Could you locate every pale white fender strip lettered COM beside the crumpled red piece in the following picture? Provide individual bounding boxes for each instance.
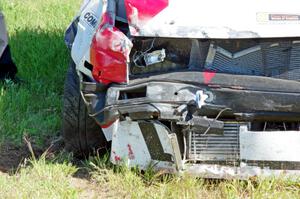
[71,0,106,77]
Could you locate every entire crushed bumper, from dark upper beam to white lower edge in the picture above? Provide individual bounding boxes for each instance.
[83,72,300,178]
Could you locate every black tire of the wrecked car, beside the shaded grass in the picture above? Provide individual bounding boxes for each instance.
[62,62,107,157]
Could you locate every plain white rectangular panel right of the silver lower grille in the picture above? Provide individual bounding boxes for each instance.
[240,126,300,162]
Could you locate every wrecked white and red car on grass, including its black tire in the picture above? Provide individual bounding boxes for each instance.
[63,0,300,178]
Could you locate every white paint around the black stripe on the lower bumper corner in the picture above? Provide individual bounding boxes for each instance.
[111,121,176,172]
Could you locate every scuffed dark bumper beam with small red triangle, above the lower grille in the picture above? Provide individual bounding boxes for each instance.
[90,72,300,124]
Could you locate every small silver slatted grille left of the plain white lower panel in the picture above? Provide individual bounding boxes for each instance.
[187,123,240,163]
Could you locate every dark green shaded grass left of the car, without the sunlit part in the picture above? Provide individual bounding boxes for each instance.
[0,30,69,146]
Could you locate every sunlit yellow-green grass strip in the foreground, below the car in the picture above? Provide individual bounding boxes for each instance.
[0,152,300,199]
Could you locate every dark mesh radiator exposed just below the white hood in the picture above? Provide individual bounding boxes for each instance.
[205,40,300,80]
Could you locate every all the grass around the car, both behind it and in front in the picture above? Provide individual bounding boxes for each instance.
[0,0,300,199]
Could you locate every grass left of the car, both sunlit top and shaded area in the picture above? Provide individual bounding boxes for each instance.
[0,0,80,144]
